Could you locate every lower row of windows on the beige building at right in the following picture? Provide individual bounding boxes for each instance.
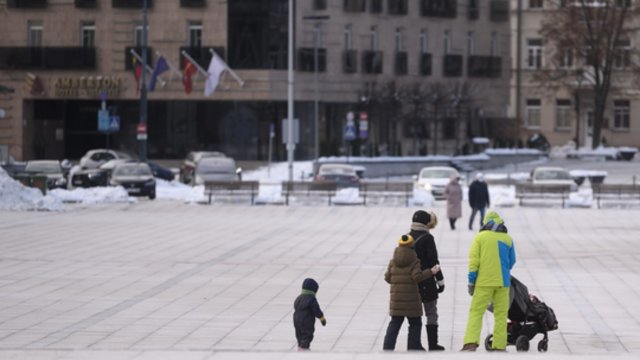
[525,99,631,130]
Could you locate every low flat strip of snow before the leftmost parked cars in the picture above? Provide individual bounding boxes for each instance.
[49,186,136,204]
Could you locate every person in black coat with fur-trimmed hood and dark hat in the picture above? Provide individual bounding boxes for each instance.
[409,210,444,351]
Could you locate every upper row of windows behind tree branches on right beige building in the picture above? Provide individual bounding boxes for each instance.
[525,38,632,69]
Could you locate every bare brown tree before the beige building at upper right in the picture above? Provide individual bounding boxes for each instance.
[534,0,640,148]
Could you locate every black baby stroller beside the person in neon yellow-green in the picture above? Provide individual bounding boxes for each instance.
[484,276,558,352]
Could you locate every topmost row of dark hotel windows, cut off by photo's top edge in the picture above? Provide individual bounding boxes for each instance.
[313,0,509,21]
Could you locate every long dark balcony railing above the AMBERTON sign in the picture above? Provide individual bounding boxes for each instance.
[0,47,96,70]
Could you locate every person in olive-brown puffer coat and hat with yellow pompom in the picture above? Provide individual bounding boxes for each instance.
[383,234,440,351]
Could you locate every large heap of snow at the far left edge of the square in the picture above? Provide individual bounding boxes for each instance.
[0,168,64,211]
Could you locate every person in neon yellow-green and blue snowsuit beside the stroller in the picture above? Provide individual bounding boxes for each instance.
[461,211,516,351]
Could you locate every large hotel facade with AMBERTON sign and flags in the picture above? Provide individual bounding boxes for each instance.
[0,0,511,160]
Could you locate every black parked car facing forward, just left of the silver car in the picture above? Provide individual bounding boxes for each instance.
[109,162,156,200]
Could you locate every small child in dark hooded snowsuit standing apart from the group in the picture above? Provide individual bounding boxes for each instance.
[293,278,327,350]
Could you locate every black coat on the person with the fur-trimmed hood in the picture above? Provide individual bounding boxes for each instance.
[409,230,444,302]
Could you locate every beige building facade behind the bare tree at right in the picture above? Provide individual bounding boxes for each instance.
[509,0,640,147]
